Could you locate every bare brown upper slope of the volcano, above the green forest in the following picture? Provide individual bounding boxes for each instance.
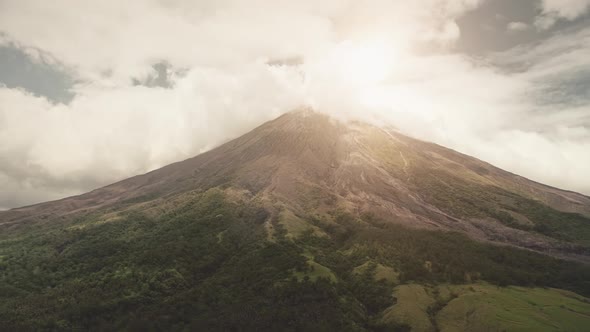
[0,110,590,259]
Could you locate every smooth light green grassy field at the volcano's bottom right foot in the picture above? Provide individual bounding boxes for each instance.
[382,283,590,332]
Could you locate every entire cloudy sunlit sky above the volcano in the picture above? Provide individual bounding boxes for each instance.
[0,0,590,209]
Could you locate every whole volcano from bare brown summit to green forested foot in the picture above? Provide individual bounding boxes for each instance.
[0,111,590,331]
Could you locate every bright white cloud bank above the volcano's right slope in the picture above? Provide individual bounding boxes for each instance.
[356,28,590,194]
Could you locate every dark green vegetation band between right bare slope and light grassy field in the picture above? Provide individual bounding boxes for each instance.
[314,210,590,295]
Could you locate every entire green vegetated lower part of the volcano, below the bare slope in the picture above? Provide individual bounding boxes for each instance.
[0,189,590,331]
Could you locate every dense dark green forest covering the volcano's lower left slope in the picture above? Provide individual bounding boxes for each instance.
[0,190,376,331]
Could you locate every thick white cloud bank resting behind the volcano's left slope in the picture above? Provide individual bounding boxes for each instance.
[0,64,301,207]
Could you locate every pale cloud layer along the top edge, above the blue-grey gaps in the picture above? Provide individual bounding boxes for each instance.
[0,0,479,84]
